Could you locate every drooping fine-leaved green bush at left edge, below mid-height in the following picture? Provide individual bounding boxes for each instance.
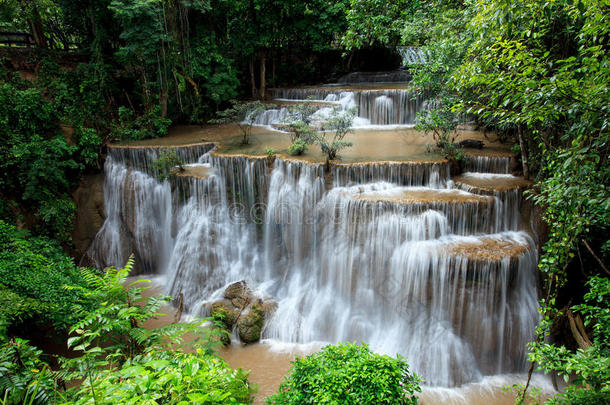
[0,221,86,337]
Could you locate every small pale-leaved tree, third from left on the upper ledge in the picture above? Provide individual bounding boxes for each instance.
[314,108,356,163]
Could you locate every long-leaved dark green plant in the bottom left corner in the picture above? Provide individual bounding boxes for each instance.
[0,338,57,405]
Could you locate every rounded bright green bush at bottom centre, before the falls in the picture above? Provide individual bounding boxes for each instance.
[267,343,421,405]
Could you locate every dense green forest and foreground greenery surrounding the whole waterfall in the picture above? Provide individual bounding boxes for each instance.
[0,0,610,404]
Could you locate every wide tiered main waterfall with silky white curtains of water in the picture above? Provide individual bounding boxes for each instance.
[88,143,538,387]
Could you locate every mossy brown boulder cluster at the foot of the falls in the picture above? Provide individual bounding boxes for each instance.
[210,280,277,344]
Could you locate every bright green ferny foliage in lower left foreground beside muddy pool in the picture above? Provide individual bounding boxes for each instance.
[62,257,253,404]
